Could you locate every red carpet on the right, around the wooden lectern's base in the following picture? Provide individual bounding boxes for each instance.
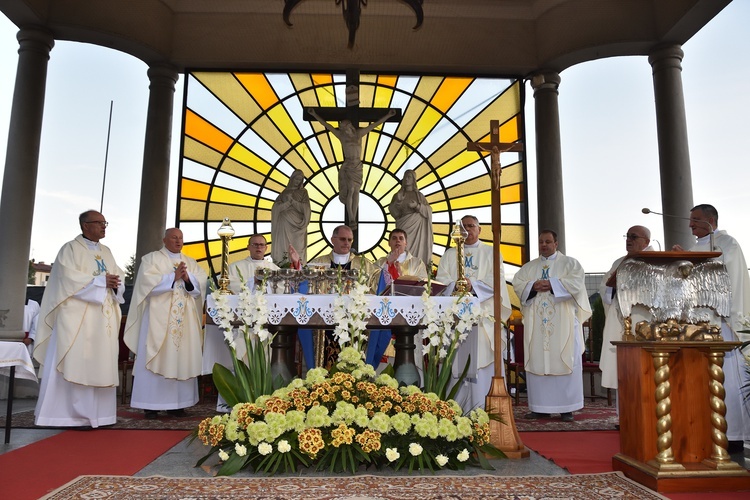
[519,431,750,500]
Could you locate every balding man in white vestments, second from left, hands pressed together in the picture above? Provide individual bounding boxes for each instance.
[124,228,207,419]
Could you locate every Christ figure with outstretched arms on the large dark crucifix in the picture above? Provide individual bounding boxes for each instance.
[308,108,396,230]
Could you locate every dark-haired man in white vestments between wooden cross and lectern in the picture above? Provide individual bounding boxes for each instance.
[513,230,591,422]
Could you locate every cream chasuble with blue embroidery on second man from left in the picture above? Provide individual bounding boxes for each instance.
[125,248,207,380]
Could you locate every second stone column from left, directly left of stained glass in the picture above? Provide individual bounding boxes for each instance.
[135,66,179,270]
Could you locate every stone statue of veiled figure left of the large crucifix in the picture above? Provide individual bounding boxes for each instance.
[271,170,310,265]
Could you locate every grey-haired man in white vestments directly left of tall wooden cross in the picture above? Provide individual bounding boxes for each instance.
[435,215,511,410]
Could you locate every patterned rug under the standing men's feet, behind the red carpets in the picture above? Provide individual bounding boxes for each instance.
[0,398,618,432]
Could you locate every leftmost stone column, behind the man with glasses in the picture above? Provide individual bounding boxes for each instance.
[0,28,55,340]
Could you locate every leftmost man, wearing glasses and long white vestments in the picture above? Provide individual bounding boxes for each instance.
[34,210,125,427]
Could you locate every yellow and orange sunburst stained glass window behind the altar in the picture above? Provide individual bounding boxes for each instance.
[177,72,528,274]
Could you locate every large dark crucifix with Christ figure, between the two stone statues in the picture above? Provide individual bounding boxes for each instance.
[302,69,401,242]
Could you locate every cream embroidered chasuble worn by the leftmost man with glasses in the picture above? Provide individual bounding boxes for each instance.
[34,235,125,387]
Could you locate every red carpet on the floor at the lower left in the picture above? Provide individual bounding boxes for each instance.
[0,429,190,500]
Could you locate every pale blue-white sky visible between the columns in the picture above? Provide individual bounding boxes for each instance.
[0,0,750,273]
